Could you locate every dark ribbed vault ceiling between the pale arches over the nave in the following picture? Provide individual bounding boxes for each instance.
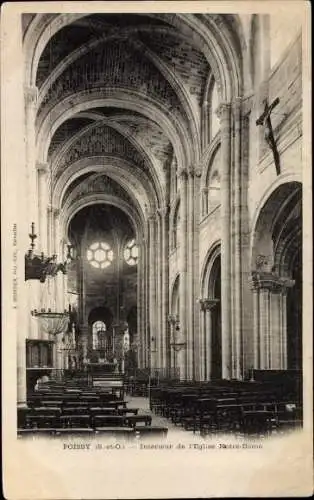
[28,14,228,227]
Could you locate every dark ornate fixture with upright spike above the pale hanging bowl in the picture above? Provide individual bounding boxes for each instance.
[25,222,66,283]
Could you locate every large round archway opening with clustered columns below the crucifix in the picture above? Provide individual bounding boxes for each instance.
[252,182,302,372]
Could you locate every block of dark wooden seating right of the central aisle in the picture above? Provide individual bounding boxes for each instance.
[150,381,302,435]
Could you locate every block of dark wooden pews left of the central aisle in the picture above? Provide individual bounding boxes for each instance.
[18,384,168,436]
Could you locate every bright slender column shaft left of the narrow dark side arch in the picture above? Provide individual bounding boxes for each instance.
[178,170,188,380]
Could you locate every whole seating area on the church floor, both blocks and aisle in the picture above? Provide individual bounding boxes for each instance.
[18,372,302,442]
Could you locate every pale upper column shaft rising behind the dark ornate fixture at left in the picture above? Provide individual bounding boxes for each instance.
[36,162,49,255]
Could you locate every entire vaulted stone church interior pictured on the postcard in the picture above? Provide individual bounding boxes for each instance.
[7,13,303,436]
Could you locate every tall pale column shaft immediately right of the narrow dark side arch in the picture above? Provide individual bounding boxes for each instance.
[218,103,232,379]
